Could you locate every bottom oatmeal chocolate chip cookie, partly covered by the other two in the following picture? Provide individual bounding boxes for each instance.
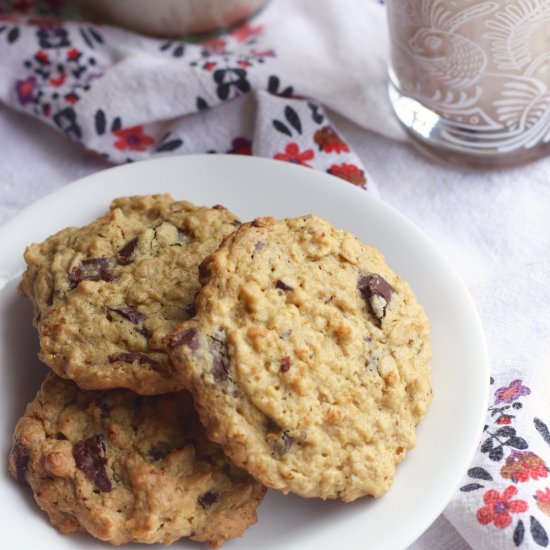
[9,373,265,547]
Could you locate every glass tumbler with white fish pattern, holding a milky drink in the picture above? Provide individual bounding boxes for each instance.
[386,0,550,168]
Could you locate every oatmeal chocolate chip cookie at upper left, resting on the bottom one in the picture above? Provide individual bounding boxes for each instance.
[20,195,239,395]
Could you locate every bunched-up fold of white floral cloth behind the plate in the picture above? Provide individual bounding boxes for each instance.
[0,0,400,196]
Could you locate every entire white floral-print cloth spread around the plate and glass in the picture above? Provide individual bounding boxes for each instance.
[0,0,550,549]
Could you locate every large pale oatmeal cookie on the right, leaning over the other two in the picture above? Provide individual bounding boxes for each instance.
[169,216,432,501]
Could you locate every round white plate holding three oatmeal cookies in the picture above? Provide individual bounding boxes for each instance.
[0,156,489,550]
